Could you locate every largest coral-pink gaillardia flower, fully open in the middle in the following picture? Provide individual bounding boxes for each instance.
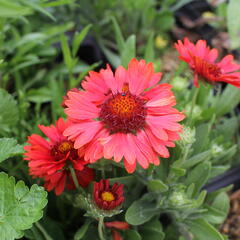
[63,59,184,173]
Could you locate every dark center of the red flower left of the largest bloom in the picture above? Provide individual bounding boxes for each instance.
[51,140,78,161]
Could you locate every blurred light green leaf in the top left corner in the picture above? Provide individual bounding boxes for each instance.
[0,0,32,18]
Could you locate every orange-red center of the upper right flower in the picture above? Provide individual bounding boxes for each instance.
[195,57,222,82]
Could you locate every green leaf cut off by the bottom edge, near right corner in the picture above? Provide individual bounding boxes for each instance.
[186,219,224,240]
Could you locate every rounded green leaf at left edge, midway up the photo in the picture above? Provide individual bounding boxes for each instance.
[0,89,19,129]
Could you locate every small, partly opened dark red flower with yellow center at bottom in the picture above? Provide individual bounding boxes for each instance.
[93,179,124,210]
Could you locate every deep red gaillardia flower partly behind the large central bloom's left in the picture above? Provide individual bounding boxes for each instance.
[24,118,94,195]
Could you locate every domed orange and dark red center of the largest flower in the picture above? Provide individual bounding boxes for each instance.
[99,92,146,134]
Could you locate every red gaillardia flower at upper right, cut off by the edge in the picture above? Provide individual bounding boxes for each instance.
[175,38,240,87]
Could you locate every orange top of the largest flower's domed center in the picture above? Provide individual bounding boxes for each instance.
[109,93,137,115]
